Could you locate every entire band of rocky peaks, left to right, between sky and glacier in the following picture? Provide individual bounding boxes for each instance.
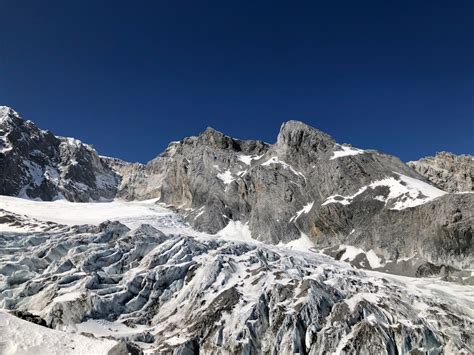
[0,108,474,272]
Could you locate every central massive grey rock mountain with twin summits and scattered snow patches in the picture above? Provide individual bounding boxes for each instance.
[112,121,474,274]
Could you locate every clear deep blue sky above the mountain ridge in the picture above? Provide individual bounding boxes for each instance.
[0,0,474,162]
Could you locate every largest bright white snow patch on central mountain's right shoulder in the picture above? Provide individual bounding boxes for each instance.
[322,172,446,210]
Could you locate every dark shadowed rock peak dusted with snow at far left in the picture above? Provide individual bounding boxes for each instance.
[0,106,119,202]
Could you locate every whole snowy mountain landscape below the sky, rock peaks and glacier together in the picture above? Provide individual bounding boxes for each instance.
[0,107,474,355]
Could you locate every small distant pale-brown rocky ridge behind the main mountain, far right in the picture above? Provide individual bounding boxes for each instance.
[408,152,474,192]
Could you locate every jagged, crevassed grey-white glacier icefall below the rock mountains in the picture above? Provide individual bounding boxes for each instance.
[0,220,474,355]
